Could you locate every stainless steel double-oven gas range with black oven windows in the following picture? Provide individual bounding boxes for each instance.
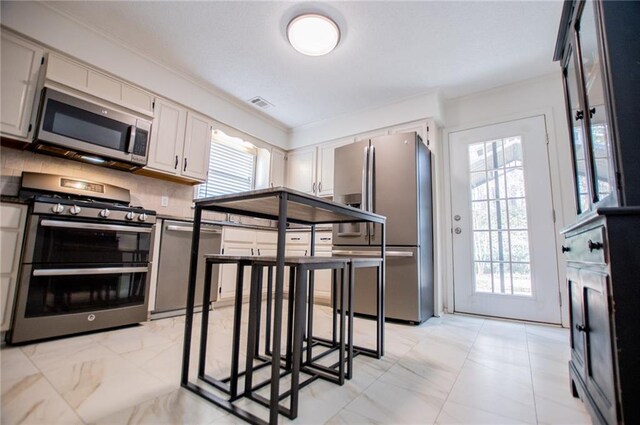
[8,172,156,343]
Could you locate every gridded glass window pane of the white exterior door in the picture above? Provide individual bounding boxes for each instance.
[469,137,532,296]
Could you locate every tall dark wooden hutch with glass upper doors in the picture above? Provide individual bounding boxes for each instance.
[555,0,640,424]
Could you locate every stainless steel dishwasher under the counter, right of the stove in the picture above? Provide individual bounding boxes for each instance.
[152,220,222,318]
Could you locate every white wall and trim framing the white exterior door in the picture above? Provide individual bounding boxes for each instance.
[437,72,575,325]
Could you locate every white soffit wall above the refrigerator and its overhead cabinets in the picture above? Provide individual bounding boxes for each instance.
[289,92,442,149]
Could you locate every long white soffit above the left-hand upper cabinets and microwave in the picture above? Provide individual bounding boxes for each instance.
[1,1,289,148]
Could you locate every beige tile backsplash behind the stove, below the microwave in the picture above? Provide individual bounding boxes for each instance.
[0,146,194,217]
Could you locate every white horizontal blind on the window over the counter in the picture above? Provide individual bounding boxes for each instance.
[197,139,256,198]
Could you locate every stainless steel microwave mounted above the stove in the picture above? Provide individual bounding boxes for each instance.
[36,87,151,170]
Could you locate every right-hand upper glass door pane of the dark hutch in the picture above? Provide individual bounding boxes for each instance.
[578,1,614,200]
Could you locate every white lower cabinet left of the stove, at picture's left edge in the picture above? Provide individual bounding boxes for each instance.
[0,204,27,332]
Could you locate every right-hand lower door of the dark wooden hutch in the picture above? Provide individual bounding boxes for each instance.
[581,270,616,423]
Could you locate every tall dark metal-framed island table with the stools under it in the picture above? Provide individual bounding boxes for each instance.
[181,187,386,424]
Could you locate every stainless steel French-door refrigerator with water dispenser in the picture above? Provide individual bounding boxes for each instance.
[333,133,434,324]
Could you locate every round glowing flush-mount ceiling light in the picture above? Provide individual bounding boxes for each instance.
[287,13,340,56]
